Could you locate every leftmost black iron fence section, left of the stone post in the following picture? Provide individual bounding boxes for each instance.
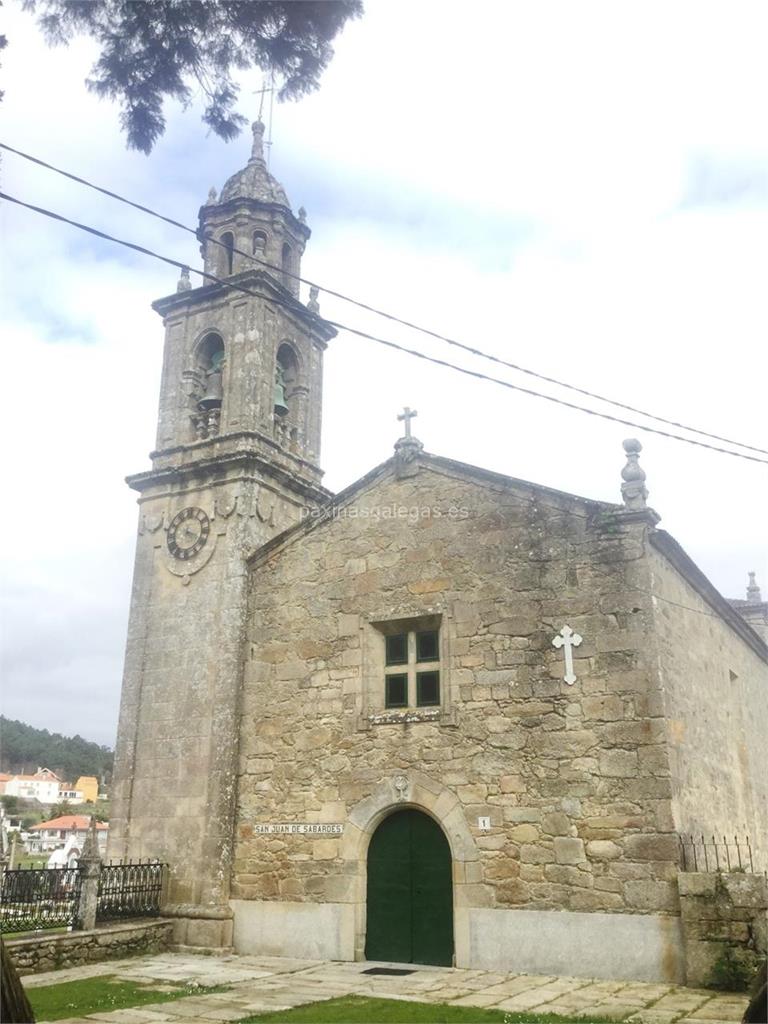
[0,867,81,932]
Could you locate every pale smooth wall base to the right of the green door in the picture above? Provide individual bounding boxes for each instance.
[466,907,685,983]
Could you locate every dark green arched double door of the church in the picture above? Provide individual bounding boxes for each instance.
[366,810,454,967]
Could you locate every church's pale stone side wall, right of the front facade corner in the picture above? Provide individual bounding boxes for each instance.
[648,546,768,870]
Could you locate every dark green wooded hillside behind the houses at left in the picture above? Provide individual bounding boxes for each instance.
[0,715,114,782]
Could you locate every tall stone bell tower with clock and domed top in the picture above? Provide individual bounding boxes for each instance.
[109,122,336,946]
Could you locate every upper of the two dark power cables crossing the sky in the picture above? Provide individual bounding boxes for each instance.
[0,138,768,455]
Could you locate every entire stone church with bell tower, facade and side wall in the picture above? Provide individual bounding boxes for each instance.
[110,123,768,981]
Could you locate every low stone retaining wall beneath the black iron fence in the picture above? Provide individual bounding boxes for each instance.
[5,919,173,975]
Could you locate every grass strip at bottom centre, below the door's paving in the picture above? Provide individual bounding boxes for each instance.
[238,995,611,1024]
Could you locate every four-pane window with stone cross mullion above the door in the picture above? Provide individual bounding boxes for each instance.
[384,630,440,709]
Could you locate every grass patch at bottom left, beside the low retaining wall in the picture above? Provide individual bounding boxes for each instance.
[27,975,226,1021]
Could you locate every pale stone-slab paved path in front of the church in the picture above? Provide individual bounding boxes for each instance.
[24,953,748,1024]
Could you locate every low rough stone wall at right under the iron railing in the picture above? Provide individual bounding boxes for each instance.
[678,871,768,988]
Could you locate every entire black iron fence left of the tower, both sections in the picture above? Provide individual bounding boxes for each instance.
[0,860,166,934]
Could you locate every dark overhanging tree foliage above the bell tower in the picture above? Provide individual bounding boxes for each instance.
[25,0,362,153]
